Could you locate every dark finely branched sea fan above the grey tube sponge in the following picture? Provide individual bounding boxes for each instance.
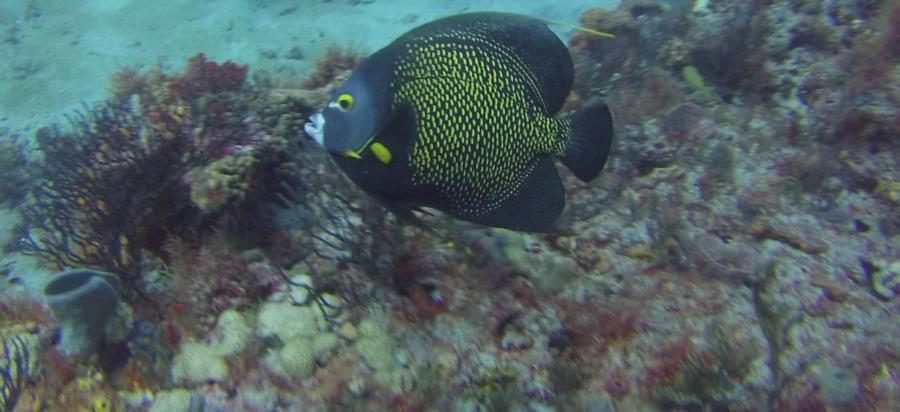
[21,103,188,284]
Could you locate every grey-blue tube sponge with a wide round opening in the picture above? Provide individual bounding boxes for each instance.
[44,269,119,355]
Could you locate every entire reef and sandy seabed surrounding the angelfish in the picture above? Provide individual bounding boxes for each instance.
[0,0,900,412]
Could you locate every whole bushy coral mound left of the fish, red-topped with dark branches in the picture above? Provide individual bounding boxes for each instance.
[19,54,298,294]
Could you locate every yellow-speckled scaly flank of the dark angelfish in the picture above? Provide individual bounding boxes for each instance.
[392,26,566,214]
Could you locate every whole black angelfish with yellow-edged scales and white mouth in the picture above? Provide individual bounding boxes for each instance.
[305,12,613,231]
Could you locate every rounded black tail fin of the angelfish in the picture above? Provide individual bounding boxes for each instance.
[562,101,613,182]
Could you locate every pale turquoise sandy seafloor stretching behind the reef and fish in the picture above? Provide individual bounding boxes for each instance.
[0,0,618,135]
